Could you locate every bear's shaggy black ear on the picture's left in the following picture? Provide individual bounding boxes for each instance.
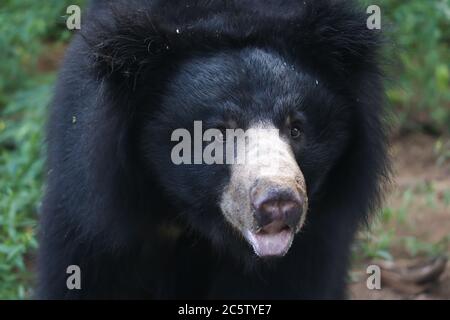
[82,2,176,81]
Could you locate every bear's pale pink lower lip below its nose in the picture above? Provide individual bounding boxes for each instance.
[244,228,294,257]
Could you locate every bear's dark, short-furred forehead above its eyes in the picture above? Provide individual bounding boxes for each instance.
[163,48,307,112]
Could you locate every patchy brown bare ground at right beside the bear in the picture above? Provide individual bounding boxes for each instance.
[349,134,450,299]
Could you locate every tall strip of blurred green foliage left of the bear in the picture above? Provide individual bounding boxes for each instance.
[0,0,80,299]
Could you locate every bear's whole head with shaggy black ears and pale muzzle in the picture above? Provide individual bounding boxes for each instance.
[86,1,384,257]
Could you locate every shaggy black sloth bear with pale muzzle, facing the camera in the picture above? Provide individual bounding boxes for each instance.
[37,0,388,299]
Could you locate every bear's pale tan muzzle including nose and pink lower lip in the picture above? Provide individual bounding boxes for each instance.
[220,123,308,257]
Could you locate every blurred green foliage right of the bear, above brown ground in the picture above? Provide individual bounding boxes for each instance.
[376,0,450,133]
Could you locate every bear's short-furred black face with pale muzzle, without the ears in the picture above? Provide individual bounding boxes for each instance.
[143,49,351,257]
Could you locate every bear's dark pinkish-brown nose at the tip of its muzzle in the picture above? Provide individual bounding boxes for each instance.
[250,189,303,233]
